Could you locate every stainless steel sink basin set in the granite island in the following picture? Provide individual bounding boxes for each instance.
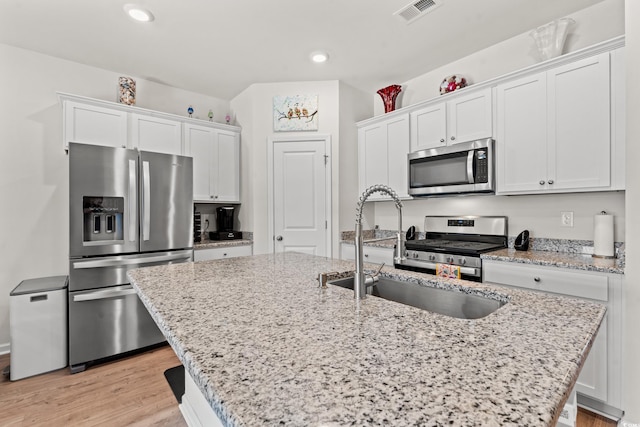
[327,277,506,319]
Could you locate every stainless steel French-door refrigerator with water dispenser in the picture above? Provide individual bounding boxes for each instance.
[68,143,193,372]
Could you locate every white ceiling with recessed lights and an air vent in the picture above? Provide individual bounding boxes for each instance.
[0,0,603,99]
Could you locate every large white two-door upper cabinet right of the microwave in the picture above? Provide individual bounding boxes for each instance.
[496,53,611,194]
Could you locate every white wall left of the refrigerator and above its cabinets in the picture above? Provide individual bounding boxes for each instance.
[0,44,229,353]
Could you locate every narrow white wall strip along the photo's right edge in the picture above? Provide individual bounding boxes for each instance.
[622,0,640,426]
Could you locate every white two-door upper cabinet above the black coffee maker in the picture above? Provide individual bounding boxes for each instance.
[184,123,240,203]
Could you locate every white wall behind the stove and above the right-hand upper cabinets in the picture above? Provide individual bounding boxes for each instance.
[375,0,625,242]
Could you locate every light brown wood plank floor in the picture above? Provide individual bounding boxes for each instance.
[0,346,616,427]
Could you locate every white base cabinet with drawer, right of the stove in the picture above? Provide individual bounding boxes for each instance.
[482,260,622,412]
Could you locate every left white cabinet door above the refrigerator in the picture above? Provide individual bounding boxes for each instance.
[62,101,129,150]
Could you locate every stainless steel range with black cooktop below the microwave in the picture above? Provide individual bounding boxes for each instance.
[395,216,507,282]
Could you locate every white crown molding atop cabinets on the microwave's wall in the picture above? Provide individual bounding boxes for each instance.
[356,36,625,127]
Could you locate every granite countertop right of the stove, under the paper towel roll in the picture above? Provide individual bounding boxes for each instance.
[480,249,624,274]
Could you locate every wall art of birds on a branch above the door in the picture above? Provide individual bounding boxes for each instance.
[273,95,318,132]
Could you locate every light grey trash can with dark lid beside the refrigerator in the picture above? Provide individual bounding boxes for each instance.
[9,276,68,381]
